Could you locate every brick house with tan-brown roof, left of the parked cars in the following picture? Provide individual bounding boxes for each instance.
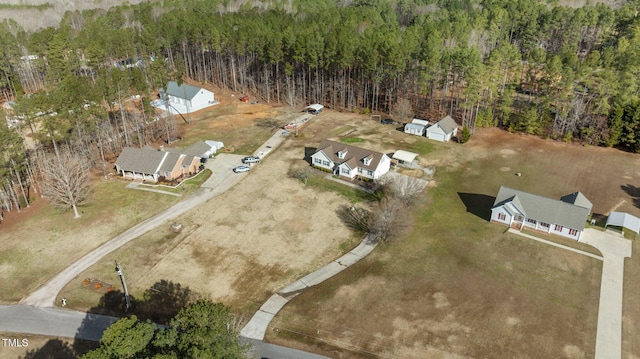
[116,147,200,182]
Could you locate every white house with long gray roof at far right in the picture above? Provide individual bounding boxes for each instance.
[491,186,593,240]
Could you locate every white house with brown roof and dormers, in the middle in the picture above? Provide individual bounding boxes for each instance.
[311,140,391,180]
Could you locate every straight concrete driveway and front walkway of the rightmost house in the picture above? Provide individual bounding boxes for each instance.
[509,228,631,359]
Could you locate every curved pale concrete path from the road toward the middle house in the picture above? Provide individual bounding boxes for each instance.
[240,236,377,340]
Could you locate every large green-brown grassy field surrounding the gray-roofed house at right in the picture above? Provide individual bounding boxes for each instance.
[267,130,640,358]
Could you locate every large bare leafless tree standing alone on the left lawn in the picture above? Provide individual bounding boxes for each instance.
[38,148,90,218]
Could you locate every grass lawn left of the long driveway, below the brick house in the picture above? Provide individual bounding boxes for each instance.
[0,179,188,303]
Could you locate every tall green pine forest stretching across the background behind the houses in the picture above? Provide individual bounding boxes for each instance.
[0,0,640,218]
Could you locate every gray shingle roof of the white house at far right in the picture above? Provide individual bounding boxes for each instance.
[492,186,590,231]
